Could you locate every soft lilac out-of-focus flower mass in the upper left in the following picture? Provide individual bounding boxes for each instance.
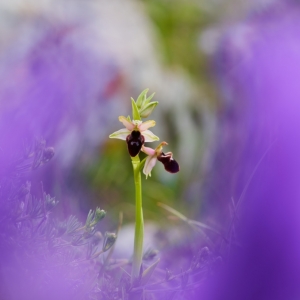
[0,19,120,170]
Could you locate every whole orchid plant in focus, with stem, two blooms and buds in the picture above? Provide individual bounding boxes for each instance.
[109,89,179,286]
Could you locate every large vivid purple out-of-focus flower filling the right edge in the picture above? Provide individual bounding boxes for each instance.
[199,5,300,300]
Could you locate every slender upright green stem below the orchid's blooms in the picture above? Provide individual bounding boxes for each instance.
[131,155,144,283]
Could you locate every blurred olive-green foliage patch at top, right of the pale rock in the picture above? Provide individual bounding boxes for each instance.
[143,0,211,77]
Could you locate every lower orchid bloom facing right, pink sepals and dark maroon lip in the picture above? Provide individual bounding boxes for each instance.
[142,142,179,178]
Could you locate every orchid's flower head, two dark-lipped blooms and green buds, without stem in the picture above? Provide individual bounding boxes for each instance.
[109,89,179,177]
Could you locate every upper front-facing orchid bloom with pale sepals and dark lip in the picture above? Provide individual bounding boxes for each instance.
[109,116,159,157]
